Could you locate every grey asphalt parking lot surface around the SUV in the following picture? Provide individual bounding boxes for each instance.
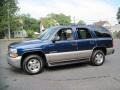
[0,40,120,90]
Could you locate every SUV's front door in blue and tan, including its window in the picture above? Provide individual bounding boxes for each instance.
[47,28,77,62]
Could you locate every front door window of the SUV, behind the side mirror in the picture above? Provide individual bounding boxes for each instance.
[57,28,73,41]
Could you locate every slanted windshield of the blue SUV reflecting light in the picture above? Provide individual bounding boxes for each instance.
[38,28,55,40]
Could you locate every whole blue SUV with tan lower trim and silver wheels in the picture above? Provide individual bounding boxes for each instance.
[8,25,114,75]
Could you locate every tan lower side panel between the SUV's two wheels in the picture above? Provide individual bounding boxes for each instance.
[45,50,93,63]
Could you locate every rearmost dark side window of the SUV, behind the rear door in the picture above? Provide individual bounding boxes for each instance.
[94,29,111,38]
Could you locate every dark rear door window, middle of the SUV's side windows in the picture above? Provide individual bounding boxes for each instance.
[77,28,91,39]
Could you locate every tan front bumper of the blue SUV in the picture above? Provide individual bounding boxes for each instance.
[7,56,22,68]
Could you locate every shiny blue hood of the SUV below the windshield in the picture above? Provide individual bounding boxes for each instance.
[8,39,46,48]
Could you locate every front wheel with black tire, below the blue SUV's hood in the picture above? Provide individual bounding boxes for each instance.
[22,55,44,75]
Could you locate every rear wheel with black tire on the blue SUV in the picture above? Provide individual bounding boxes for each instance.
[90,50,105,66]
